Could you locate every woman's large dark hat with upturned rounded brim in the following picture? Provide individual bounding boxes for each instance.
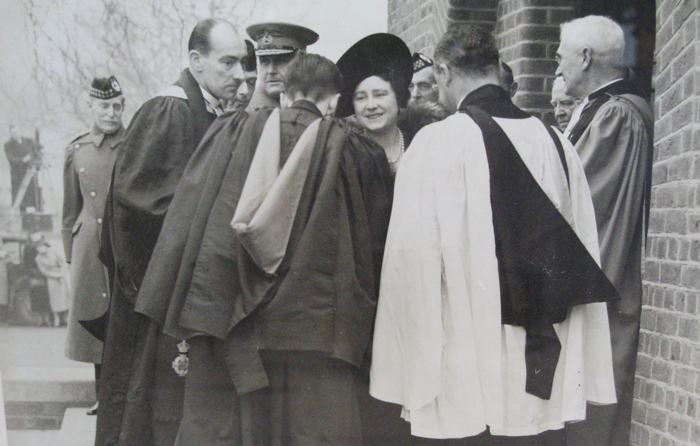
[335,33,413,118]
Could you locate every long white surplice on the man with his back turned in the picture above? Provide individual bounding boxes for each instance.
[370,113,615,438]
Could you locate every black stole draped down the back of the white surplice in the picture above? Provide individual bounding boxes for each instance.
[459,85,619,399]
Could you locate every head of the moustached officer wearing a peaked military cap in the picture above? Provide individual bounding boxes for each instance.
[246,22,318,113]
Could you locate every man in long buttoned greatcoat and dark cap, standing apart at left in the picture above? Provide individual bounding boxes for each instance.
[61,76,124,415]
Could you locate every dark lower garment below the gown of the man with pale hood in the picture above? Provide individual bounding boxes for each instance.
[176,337,363,446]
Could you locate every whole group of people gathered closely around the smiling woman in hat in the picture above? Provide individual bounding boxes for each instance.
[57,16,653,446]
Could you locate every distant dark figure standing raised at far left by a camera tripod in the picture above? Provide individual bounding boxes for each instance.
[5,125,40,210]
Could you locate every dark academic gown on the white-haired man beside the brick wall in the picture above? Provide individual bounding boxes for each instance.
[567,81,654,446]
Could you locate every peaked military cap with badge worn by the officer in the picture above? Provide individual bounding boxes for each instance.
[246,22,318,56]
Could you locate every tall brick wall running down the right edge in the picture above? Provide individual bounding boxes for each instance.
[632,0,700,446]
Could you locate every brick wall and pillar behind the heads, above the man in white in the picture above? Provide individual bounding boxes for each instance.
[388,0,574,115]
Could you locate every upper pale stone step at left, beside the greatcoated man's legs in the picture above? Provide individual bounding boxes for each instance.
[3,367,95,430]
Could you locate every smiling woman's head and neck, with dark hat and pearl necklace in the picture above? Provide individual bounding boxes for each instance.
[336,33,413,172]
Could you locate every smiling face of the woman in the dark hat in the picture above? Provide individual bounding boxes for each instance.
[352,76,399,134]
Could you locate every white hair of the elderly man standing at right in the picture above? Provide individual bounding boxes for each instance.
[561,15,625,68]
